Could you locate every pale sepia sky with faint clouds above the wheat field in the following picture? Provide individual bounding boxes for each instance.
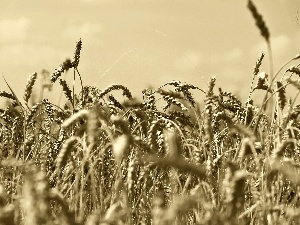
[0,0,300,105]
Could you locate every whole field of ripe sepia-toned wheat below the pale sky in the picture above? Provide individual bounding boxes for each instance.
[0,1,300,225]
